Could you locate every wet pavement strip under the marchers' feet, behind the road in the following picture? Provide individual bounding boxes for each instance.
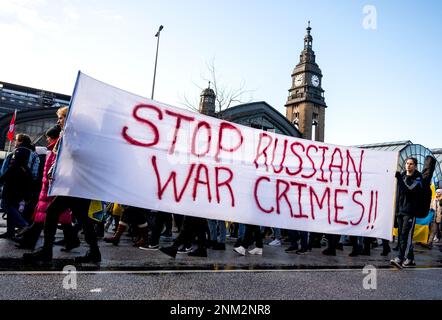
[0,221,442,271]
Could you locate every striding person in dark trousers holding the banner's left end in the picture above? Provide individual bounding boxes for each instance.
[23,107,101,263]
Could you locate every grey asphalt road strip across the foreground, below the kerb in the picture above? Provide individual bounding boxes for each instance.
[0,268,442,300]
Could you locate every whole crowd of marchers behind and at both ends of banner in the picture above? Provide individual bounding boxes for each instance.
[0,107,442,268]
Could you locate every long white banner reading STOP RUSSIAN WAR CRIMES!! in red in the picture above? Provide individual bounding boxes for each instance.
[50,73,397,239]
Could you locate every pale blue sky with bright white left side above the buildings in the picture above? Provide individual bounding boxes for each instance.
[0,0,442,148]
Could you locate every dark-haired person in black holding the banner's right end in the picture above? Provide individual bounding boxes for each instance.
[390,157,423,268]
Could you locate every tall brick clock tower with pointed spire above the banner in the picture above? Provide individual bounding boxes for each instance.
[285,21,327,142]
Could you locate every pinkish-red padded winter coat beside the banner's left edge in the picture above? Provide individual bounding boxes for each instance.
[34,142,72,224]
